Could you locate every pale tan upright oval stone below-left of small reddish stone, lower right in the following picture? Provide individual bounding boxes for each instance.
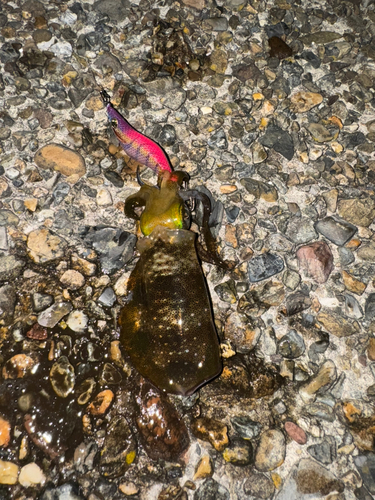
[255,429,286,472]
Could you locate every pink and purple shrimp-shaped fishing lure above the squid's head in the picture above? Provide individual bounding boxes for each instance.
[100,90,172,174]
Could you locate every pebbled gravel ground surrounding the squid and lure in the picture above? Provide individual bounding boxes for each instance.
[0,0,375,500]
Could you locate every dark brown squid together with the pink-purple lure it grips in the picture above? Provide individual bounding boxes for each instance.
[101,91,224,396]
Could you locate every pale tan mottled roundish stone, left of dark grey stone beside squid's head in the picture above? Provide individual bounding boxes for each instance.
[27,228,67,264]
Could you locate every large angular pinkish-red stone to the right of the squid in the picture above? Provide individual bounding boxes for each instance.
[296,241,334,283]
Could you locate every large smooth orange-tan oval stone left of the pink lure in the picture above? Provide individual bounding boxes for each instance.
[34,144,86,181]
